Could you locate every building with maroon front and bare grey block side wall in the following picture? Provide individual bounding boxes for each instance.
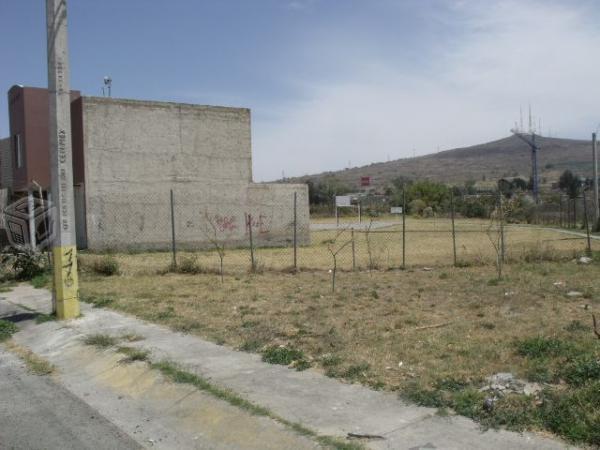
[0,86,309,250]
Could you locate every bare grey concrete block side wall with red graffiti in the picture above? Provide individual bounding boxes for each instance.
[82,97,309,250]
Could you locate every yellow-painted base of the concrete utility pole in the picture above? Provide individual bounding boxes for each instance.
[52,245,79,319]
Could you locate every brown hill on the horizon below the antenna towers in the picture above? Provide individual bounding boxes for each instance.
[290,136,592,188]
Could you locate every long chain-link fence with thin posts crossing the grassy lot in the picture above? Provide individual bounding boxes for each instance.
[75,191,600,274]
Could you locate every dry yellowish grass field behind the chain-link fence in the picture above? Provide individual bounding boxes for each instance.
[78,217,600,274]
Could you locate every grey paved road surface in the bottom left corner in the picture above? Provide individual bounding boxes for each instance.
[0,345,141,450]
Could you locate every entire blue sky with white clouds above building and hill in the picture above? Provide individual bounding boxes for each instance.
[0,0,600,180]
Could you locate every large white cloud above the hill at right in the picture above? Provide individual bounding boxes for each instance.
[253,0,600,180]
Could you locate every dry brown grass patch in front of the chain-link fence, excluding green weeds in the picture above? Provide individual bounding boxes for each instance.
[81,256,600,390]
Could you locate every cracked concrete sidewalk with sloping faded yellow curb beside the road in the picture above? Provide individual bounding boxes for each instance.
[0,285,568,449]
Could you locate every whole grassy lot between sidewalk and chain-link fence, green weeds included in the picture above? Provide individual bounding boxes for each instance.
[81,255,600,445]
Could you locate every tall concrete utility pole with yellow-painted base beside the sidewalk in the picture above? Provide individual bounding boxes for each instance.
[46,0,79,319]
